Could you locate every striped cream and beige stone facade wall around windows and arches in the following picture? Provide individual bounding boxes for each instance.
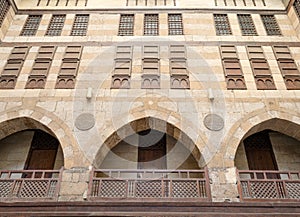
[0,0,300,209]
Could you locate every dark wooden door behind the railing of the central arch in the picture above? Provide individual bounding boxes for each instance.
[138,131,166,169]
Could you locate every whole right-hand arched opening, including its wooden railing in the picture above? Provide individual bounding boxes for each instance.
[234,119,300,200]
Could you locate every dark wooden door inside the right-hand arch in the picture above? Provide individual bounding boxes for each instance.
[244,131,278,178]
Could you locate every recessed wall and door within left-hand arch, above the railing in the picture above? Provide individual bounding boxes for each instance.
[0,130,63,170]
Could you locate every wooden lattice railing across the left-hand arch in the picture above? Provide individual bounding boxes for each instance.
[0,170,62,201]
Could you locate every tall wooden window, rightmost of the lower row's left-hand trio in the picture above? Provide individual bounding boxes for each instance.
[56,46,82,89]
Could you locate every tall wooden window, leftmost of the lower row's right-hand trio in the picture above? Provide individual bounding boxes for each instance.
[220,45,246,89]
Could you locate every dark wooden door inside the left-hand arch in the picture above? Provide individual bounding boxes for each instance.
[24,130,59,170]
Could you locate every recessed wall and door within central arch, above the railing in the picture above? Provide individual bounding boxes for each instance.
[99,129,200,170]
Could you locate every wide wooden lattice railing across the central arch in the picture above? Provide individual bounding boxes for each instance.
[89,169,211,201]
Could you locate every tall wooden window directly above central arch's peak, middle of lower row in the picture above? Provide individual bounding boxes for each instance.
[142,45,160,89]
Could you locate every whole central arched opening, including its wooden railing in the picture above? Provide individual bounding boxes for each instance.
[90,117,210,201]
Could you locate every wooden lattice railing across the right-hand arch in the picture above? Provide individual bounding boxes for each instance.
[238,170,300,201]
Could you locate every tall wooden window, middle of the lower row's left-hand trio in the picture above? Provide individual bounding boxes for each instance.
[26,46,56,89]
